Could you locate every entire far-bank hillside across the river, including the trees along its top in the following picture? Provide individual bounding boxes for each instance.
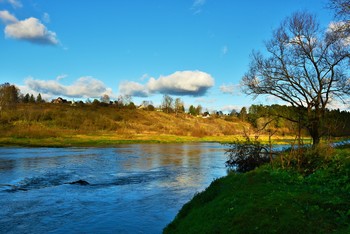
[0,83,350,145]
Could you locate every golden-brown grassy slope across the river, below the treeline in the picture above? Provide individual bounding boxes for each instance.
[0,103,296,145]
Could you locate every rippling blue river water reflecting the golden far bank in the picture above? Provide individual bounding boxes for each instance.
[0,143,227,233]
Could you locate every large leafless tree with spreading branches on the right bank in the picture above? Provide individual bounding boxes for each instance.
[242,12,350,146]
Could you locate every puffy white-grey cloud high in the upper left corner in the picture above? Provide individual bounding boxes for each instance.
[0,11,59,45]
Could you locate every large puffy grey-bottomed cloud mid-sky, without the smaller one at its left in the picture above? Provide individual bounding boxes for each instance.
[147,71,214,96]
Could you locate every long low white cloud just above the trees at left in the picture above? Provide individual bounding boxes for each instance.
[25,77,112,98]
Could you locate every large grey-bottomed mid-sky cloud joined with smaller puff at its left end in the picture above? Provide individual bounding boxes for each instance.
[119,71,214,97]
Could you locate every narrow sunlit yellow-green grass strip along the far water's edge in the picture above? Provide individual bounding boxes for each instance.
[0,133,310,147]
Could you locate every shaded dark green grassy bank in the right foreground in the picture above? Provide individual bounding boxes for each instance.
[164,149,350,233]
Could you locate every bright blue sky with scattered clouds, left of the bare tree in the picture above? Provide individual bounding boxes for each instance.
[0,0,340,112]
